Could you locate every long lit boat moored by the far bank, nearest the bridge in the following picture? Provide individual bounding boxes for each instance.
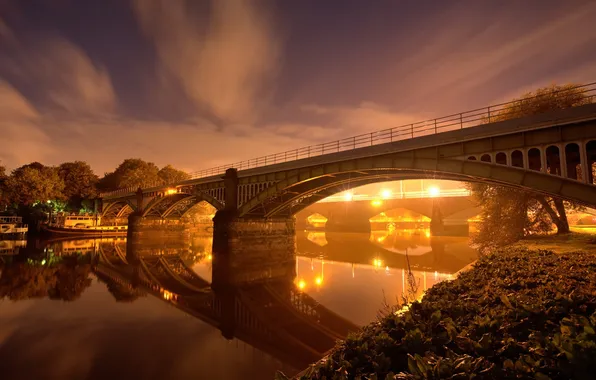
[42,213,128,236]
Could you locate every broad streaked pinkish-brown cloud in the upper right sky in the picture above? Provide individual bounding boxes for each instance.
[381,2,596,111]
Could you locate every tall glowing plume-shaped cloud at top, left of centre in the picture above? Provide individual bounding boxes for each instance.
[134,0,279,123]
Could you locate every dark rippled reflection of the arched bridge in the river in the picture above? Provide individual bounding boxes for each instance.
[94,244,358,369]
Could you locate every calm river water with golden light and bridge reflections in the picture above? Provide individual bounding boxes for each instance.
[0,230,476,379]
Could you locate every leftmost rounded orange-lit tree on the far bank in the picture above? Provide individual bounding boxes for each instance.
[4,162,64,206]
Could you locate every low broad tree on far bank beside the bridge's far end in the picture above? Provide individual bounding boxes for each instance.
[98,158,162,191]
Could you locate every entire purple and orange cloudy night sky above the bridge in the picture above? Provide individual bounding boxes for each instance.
[0,0,596,175]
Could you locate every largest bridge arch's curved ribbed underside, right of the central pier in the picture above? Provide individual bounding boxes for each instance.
[239,157,595,217]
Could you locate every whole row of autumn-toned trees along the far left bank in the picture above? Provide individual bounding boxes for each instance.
[0,158,190,215]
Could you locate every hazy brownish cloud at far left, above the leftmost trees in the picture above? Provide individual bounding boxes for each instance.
[0,37,116,116]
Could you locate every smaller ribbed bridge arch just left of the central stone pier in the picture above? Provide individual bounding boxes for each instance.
[143,192,224,219]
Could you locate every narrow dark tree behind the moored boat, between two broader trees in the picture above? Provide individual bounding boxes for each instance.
[58,161,99,210]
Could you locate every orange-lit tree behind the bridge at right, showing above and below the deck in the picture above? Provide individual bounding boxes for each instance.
[470,84,593,250]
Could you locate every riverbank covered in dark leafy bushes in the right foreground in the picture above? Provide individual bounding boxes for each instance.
[286,245,596,379]
